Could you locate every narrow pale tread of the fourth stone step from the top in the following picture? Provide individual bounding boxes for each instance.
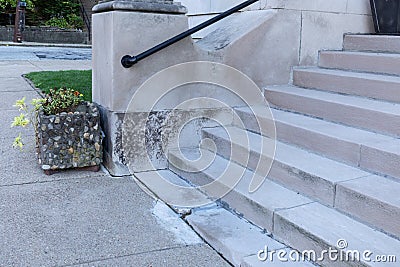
[265,85,400,116]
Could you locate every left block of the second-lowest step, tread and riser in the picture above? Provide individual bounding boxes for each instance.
[169,149,312,231]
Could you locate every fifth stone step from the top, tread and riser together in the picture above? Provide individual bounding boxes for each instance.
[236,108,400,179]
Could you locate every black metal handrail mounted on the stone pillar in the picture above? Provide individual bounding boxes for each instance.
[121,0,259,68]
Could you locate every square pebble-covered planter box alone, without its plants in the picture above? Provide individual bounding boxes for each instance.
[37,102,103,175]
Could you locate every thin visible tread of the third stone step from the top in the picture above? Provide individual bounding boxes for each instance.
[293,67,400,82]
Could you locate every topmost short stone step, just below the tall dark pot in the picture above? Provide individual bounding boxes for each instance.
[343,34,400,53]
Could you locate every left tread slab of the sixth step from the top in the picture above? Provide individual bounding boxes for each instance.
[204,127,370,184]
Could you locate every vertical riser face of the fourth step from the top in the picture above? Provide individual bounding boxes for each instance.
[265,91,400,139]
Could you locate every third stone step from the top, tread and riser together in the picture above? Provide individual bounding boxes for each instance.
[293,67,400,103]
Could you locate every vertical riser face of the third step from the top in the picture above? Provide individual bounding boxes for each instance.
[293,69,400,103]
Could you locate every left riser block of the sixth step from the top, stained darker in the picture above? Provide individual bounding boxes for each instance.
[203,129,335,206]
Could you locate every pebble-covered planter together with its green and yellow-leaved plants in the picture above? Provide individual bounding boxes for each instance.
[13,88,103,174]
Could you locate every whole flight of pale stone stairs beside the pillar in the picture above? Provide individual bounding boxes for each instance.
[160,35,400,266]
